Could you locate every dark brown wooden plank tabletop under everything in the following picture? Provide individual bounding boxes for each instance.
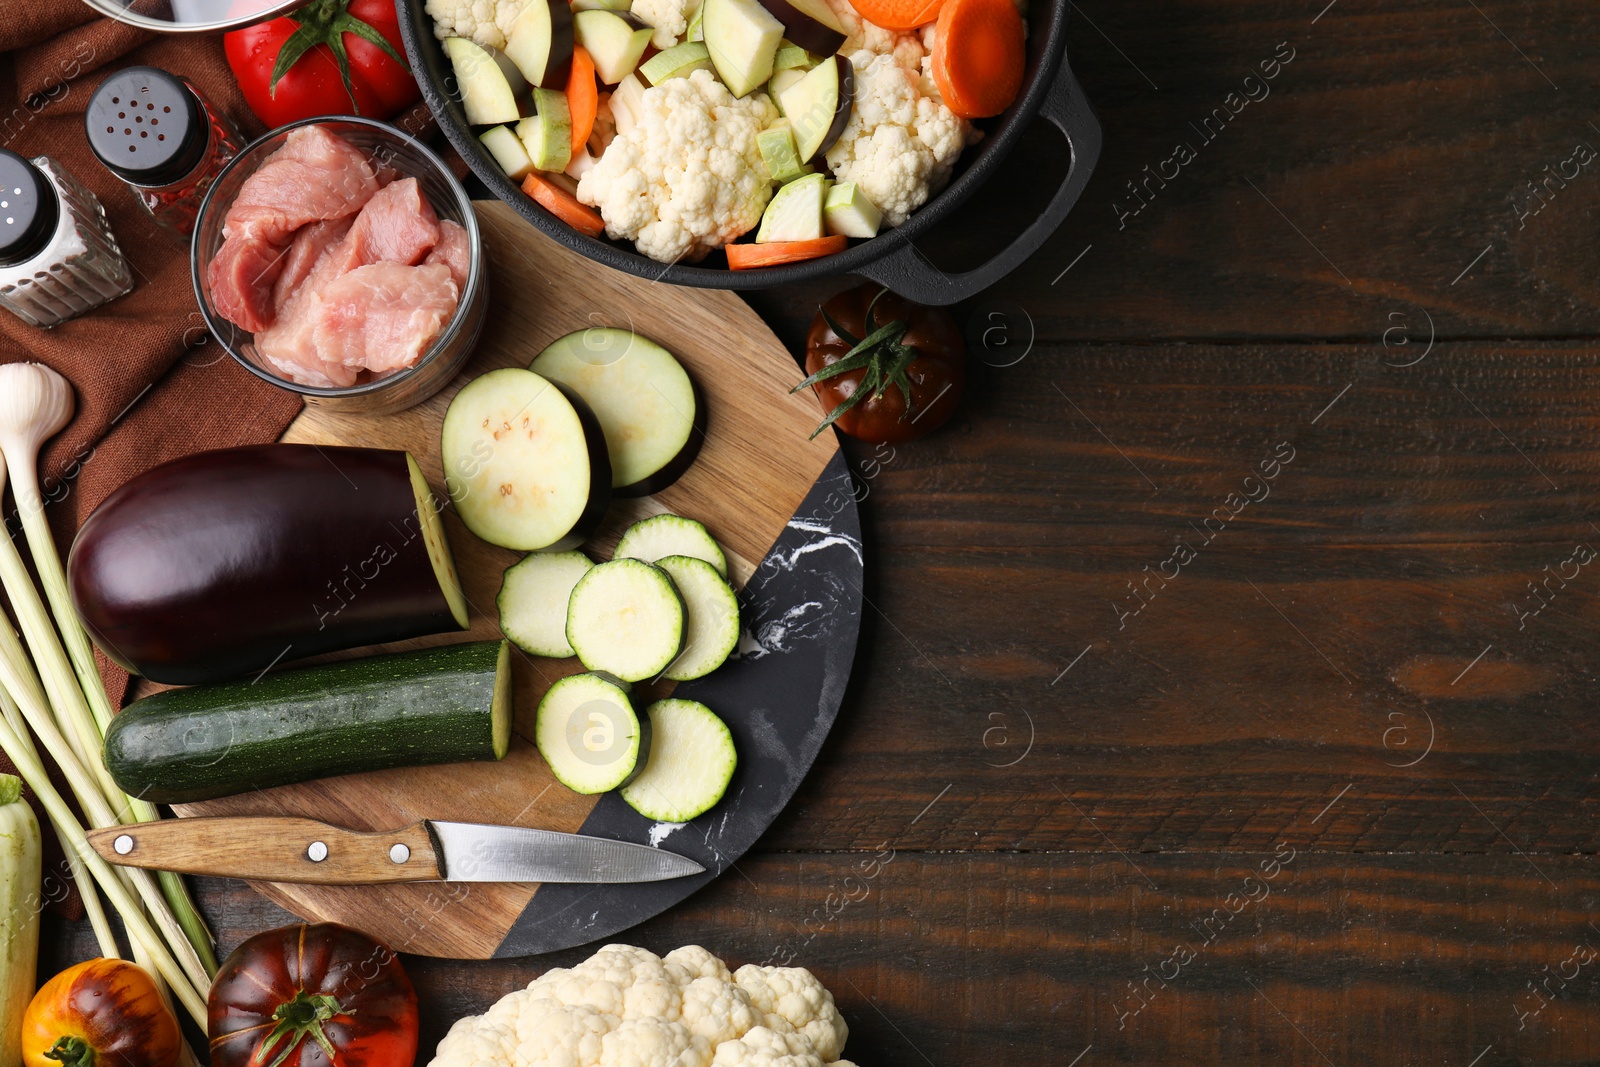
[46,0,1600,1067]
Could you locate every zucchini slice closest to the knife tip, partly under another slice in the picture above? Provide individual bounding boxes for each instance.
[622,697,739,822]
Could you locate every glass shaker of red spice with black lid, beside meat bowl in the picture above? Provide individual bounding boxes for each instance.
[83,67,243,238]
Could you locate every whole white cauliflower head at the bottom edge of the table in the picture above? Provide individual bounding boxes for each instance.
[429,940,853,1067]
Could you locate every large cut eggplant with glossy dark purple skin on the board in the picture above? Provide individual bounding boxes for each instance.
[67,445,467,685]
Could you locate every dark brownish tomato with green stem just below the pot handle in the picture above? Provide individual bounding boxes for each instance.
[795,285,966,442]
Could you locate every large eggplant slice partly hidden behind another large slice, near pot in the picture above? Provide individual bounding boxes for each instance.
[528,329,706,496]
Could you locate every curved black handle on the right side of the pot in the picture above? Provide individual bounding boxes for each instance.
[856,59,1101,306]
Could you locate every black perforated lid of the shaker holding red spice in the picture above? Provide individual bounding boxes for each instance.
[83,67,211,186]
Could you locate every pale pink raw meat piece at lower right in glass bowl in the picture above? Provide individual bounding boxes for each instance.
[314,262,461,374]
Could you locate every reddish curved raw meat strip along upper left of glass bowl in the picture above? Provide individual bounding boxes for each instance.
[206,126,378,333]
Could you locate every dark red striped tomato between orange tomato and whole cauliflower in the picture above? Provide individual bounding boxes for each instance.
[208,923,416,1067]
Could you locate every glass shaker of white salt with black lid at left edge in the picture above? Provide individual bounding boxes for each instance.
[0,149,133,326]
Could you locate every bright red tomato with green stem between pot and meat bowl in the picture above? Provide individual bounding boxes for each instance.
[222,0,422,126]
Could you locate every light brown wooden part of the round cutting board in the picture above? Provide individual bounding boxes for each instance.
[179,202,859,958]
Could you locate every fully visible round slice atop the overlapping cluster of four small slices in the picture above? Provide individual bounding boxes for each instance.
[566,560,688,681]
